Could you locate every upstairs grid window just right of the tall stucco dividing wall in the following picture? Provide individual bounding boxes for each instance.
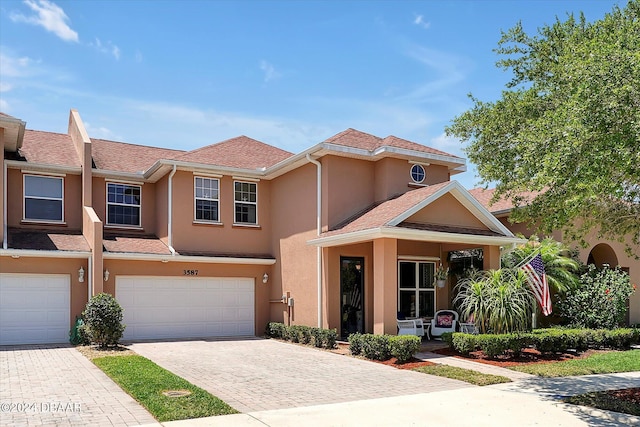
[107,182,142,227]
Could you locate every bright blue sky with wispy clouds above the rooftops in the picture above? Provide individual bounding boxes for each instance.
[0,0,626,188]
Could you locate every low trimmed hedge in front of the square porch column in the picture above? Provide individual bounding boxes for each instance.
[348,333,421,363]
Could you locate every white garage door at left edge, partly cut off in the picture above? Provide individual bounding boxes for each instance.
[0,273,71,345]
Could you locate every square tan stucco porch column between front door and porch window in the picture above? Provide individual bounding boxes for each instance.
[373,239,398,335]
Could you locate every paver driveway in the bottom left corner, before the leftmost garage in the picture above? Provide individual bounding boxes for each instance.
[0,345,156,426]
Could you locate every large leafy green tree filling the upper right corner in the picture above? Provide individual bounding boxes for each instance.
[447,0,640,255]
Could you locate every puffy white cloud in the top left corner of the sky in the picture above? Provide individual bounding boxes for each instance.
[10,0,78,42]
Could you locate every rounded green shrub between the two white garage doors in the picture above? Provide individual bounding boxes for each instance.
[82,293,125,347]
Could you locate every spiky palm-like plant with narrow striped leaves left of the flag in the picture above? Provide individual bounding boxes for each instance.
[454,268,535,334]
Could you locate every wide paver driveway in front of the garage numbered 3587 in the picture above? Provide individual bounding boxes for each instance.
[130,338,470,412]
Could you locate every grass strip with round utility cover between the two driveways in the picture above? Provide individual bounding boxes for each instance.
[93,355,238,422]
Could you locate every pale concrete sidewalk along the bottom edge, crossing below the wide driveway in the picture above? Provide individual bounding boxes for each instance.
[156,378,640,427]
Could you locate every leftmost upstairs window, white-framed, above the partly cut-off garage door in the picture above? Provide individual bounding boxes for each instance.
[24,175,64,222]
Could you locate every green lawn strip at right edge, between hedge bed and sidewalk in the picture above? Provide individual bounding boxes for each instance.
[509,350,640,377]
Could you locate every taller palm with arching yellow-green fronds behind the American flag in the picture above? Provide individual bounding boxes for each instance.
[502,234,580,295]
